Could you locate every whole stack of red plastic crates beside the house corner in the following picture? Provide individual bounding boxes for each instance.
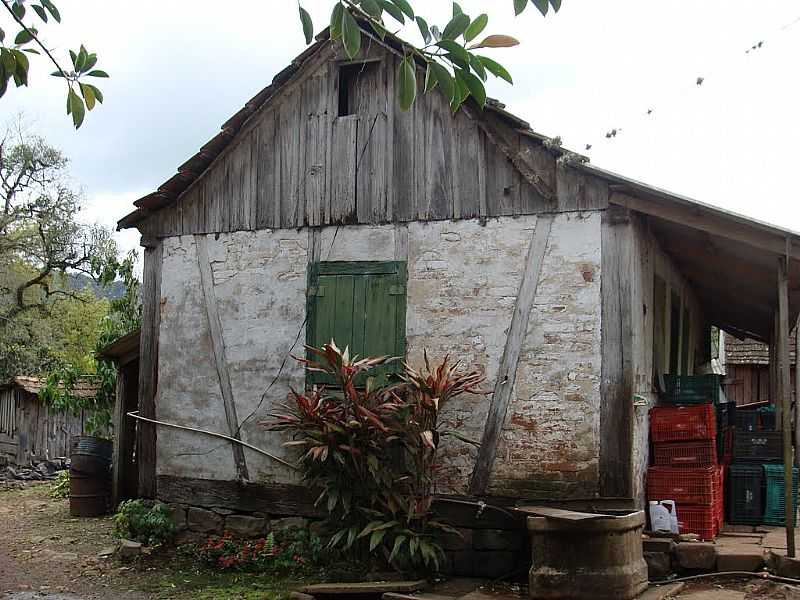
[647,404,723,540]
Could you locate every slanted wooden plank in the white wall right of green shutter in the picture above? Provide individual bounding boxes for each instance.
[470,215,554,495]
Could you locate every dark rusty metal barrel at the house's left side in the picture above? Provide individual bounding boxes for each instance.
[69,436,113,517]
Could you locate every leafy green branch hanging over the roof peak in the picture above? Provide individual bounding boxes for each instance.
[299,0,561,112]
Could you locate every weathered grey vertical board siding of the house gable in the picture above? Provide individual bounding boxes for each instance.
[140,46,592,236]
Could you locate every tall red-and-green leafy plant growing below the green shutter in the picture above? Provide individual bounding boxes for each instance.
[267,341,483,568]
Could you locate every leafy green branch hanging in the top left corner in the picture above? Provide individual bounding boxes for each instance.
[0,0,108,129]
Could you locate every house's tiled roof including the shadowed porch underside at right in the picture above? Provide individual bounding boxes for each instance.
[118,15,800,342]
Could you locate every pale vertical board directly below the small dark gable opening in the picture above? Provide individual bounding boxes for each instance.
[330,117,358,223]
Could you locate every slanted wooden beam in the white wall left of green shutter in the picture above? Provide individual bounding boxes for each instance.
[194,235,250,481]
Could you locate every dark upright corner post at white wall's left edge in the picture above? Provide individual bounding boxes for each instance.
[137,242,162,498]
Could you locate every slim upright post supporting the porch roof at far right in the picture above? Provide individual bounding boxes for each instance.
[778,258,795,558]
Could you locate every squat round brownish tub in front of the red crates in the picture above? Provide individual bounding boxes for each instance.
[528,511,647,600]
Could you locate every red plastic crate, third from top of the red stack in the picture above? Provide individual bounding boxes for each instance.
[647,466,722,506]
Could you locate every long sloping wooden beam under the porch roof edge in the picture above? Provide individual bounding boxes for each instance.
[609,191,798,256]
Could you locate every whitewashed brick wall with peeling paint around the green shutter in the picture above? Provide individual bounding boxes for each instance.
[157,212,600,497]
